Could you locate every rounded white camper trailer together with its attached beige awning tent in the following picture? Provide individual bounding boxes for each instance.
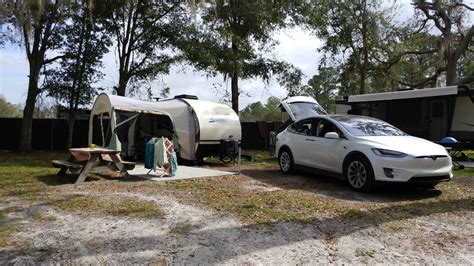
[89,93,242,162]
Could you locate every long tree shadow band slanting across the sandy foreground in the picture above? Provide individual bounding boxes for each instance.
[0,197,474,264]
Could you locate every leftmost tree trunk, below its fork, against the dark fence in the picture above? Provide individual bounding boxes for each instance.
[18,65,40,152]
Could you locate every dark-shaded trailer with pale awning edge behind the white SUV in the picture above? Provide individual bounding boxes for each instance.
[336,86,474,141]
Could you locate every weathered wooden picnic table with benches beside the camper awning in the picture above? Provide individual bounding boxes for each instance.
[52,147,135,184]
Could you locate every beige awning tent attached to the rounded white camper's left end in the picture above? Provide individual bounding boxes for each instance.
[89,93,175,159]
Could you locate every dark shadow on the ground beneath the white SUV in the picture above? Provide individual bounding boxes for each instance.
[242,170,442,202]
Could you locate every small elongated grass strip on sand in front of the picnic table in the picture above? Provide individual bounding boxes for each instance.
[49,195,162,218]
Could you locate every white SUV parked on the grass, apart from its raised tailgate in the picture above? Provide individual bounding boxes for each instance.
[275,97,453,191]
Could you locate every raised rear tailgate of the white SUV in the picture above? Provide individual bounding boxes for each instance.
[278,96,328,121]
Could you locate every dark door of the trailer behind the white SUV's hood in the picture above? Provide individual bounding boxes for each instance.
[430,100,448,140]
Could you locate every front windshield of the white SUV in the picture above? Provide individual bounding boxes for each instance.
[332,116,407,136]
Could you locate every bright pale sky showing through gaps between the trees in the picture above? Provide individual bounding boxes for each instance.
[0,0,422,109]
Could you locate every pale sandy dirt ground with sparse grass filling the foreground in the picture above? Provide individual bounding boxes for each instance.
[0,154,474,265]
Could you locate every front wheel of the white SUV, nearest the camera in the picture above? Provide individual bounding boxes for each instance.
[344,155,375,192]
